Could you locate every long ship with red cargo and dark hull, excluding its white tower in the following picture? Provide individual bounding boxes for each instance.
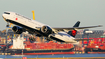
[5,41,74,55]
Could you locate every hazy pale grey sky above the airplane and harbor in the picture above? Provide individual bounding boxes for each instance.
[0,0,105,30]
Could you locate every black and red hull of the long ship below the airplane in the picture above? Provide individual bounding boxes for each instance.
[5,48,74,55]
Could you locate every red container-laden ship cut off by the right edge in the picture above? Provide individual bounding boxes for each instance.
[85,38,105,53]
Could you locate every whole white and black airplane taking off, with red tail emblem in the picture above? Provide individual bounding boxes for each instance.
[2,11,101,45]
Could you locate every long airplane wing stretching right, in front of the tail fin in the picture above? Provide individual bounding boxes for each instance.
[53,25,102,31]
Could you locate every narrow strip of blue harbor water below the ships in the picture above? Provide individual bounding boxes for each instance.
[0,54,105,58]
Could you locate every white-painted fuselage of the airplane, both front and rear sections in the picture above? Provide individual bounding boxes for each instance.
[2,12,77,43]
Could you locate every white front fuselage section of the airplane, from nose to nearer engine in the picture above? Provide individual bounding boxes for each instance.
[3,12,45,29]
